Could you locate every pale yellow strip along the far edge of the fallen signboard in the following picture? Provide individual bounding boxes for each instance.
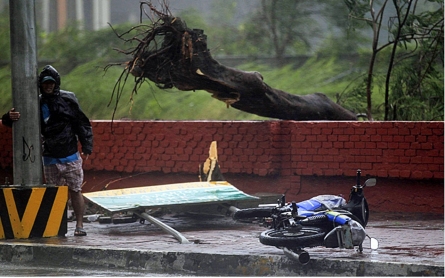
[83,181,233,198]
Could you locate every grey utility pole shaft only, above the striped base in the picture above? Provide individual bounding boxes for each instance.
[9,0,43,186]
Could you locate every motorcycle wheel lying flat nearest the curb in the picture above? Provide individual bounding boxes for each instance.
[260,227,326,249]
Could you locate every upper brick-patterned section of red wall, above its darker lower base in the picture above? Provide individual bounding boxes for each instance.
[0,121,444,180]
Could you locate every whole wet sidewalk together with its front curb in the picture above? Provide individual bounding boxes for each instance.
[0,213,444,276]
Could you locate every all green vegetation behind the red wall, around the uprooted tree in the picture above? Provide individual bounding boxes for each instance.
[0,0,444,120]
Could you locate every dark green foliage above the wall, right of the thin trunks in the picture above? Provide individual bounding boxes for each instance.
[388,1,444,121]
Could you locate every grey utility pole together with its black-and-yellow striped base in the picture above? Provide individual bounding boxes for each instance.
[0,0,68,239]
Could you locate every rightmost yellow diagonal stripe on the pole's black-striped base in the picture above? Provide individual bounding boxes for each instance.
[43,186,68,237]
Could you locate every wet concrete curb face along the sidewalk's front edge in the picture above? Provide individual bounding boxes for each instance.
[0,242,444,277]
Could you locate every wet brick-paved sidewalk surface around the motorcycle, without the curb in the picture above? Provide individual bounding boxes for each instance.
[59,213,444,266]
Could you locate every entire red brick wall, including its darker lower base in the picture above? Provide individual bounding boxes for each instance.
[0,121,444,213]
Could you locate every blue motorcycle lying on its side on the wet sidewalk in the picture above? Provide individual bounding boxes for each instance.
[232,170,378,264]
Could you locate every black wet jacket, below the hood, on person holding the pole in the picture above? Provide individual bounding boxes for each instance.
[40,90,93,158]
